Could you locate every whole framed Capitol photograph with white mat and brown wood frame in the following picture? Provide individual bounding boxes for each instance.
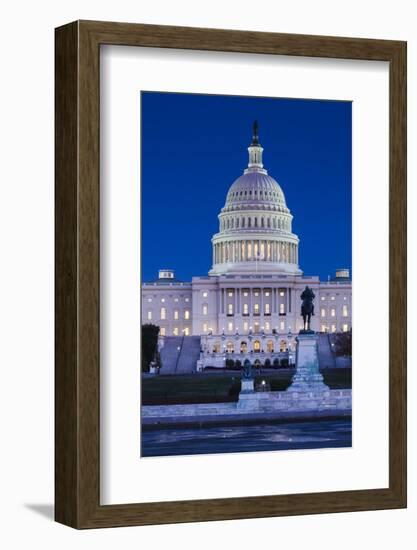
[55,21,406,528]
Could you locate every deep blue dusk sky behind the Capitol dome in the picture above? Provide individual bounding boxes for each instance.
[141,92,352,281]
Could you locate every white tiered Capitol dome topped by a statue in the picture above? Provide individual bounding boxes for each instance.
[210,122,301,275]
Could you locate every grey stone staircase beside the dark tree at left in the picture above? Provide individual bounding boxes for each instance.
[160,336,200,374]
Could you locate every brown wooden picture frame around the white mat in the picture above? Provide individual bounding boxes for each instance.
[55,21,406,528]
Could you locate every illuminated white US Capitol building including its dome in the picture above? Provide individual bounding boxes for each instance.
[142,122,352,371]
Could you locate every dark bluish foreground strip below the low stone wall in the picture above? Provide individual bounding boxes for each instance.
[141,418,352,457]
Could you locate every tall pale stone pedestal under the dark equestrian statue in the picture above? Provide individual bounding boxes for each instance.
[287,333,330,394]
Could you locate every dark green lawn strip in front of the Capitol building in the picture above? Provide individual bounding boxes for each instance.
[142,369,352,405]
